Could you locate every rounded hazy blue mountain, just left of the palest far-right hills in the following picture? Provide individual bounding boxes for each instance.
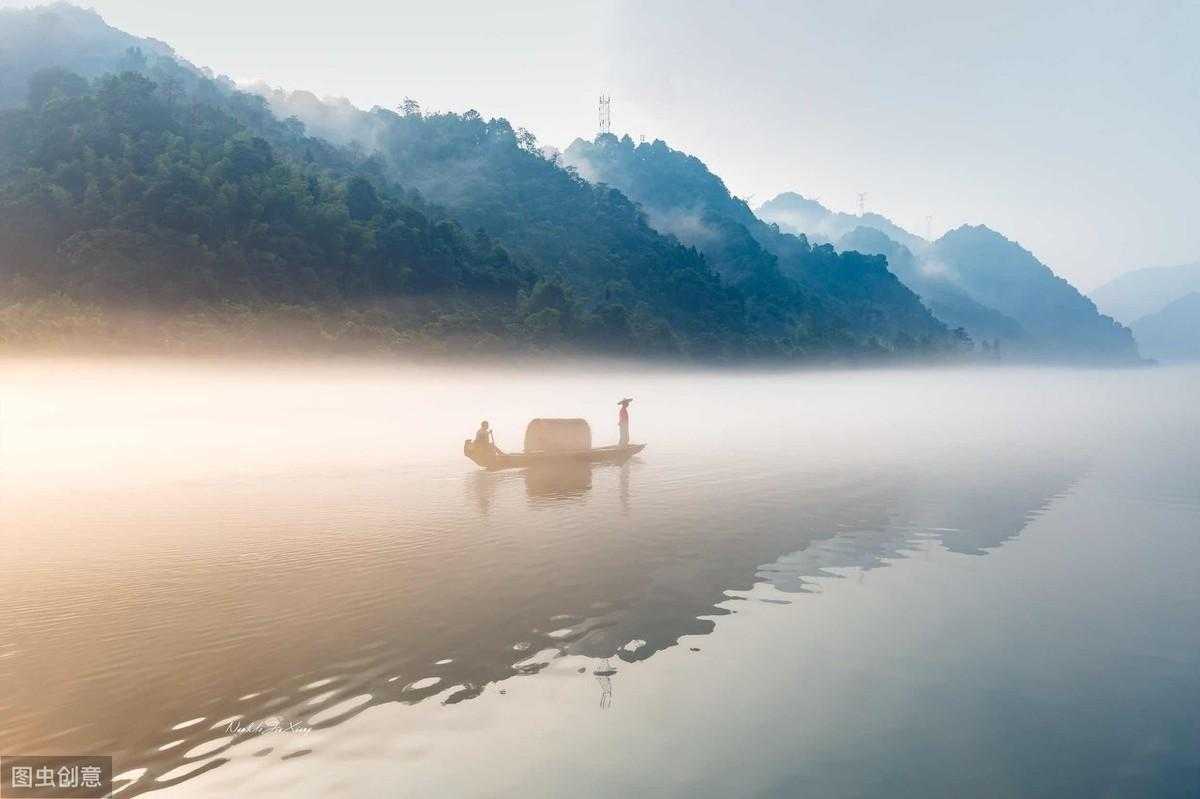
[922,226,1138,361]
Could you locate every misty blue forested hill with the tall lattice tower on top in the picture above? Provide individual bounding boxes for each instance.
[563,134,952,342]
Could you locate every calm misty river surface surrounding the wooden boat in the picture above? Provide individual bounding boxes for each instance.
[0,361,1200,797]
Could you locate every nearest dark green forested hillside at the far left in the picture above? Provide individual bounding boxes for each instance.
[0,70,554,352]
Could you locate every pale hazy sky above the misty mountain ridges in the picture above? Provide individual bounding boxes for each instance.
[0,0,1200,290]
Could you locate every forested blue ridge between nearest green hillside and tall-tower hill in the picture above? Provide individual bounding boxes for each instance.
[284,100,825,355]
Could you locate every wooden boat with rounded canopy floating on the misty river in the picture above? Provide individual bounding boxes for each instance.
[462,419,646,469]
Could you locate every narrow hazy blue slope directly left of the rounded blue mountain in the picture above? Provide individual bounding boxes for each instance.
[838,227,1026,349]
